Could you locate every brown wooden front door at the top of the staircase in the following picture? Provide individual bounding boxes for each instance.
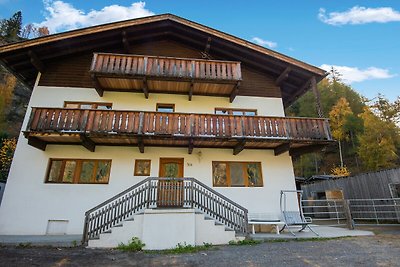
[157,158,183,208]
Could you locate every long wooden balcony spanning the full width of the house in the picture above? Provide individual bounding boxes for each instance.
[24,108,333,155]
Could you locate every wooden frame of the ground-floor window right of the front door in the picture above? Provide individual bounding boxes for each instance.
[211,160,264,188]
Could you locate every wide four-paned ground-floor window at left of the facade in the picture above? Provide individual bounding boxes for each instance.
[46,159,111,184]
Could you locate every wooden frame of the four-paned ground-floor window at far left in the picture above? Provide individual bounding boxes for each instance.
[45,158,112,184]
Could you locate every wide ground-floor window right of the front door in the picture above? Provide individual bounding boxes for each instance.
[212,161,263,187]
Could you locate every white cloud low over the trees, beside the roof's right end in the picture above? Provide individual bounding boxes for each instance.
[320,64,396,84]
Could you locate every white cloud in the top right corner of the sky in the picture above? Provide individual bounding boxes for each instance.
[318,6,400,26]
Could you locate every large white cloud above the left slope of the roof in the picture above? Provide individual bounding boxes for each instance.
[37,0,154,33]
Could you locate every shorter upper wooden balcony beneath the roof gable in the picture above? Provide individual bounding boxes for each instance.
[90,53,242,101]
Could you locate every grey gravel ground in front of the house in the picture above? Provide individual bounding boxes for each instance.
[0,228,400,267]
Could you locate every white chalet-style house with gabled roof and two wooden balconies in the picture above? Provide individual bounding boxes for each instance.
[0,14,332,249]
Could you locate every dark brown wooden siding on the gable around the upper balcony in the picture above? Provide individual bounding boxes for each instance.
[39,40,281,97]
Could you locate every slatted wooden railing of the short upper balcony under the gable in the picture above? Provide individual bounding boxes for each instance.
[90,53,242,81]
